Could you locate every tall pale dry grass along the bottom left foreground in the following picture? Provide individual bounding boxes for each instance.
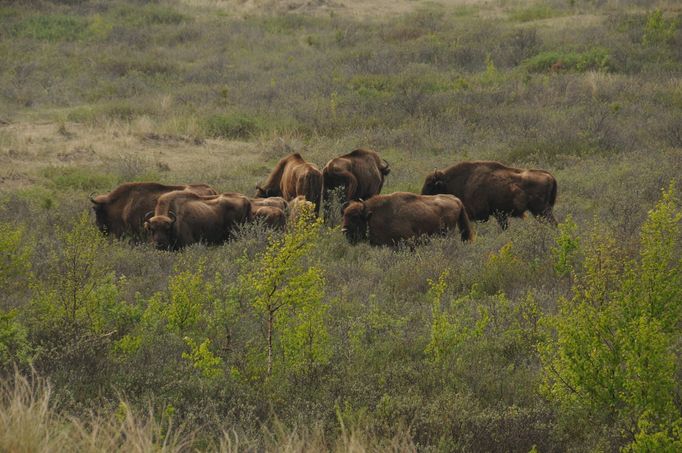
[0,372,417,453]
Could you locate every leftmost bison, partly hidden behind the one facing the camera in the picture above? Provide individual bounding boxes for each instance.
[90,182,217,240]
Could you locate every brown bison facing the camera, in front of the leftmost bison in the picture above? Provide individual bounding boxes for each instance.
[144,190,252,250]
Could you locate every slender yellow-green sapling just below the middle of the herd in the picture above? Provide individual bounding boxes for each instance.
[241,206,330,376]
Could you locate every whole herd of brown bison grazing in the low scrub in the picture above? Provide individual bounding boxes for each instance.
[90,149,557,250]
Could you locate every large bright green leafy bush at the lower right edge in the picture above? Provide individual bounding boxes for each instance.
[541,185,682,451]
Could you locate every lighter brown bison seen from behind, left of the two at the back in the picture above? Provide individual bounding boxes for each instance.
[256,153,322,211]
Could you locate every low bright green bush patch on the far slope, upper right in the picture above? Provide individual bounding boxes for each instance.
[523,47,611,72]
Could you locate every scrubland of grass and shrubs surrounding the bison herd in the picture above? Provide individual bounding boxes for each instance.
[0,0,682,452]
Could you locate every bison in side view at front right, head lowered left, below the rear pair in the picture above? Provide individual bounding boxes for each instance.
[341,192,473,245]
